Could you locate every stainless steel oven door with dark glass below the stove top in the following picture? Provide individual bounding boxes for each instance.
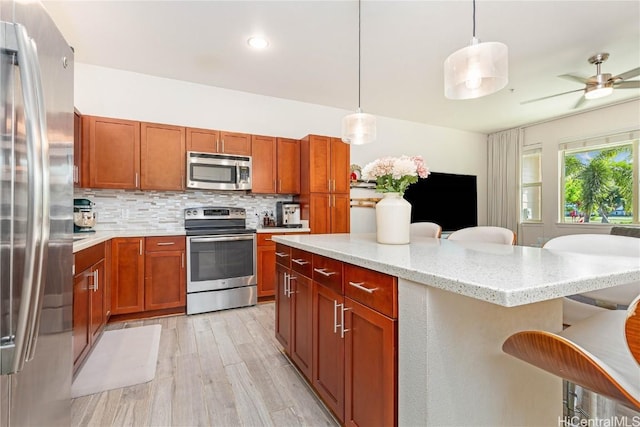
[187,233,257,292]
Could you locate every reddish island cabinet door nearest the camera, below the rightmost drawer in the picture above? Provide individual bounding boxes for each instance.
[344,298,397,426]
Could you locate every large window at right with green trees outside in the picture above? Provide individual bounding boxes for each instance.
[560,131,639,224]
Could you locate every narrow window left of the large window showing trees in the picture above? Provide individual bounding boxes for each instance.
[520,149,542,222]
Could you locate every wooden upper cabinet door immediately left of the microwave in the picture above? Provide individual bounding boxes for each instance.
[140,123,186,190]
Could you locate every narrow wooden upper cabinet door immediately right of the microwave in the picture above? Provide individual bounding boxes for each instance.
[251,135,276,194]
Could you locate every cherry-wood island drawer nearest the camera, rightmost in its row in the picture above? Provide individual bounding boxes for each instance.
[344,264,398,319]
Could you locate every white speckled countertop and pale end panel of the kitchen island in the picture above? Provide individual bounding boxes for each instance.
[274,234,640,426]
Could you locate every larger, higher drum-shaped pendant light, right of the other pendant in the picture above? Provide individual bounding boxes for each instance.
[444,0,509,99]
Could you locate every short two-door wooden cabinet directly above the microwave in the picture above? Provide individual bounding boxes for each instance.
[187,128,251,156]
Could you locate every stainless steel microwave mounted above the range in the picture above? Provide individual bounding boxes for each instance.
[187,151,251,190]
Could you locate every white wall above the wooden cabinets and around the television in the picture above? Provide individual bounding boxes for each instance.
[75,63,487,224]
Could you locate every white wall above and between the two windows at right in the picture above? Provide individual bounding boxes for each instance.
[519,100,640,244]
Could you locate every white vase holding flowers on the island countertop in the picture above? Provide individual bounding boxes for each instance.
[376,193,411,245]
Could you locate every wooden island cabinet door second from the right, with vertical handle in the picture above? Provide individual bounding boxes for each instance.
[312,282,344,422]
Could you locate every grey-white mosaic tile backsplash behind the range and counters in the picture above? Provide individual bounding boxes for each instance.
[74,188,292,231]
